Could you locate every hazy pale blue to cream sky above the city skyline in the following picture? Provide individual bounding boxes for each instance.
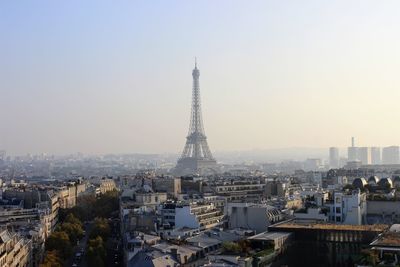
[0,0,400,154]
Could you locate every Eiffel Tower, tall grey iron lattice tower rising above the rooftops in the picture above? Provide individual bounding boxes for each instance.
[175,61,217,175]
